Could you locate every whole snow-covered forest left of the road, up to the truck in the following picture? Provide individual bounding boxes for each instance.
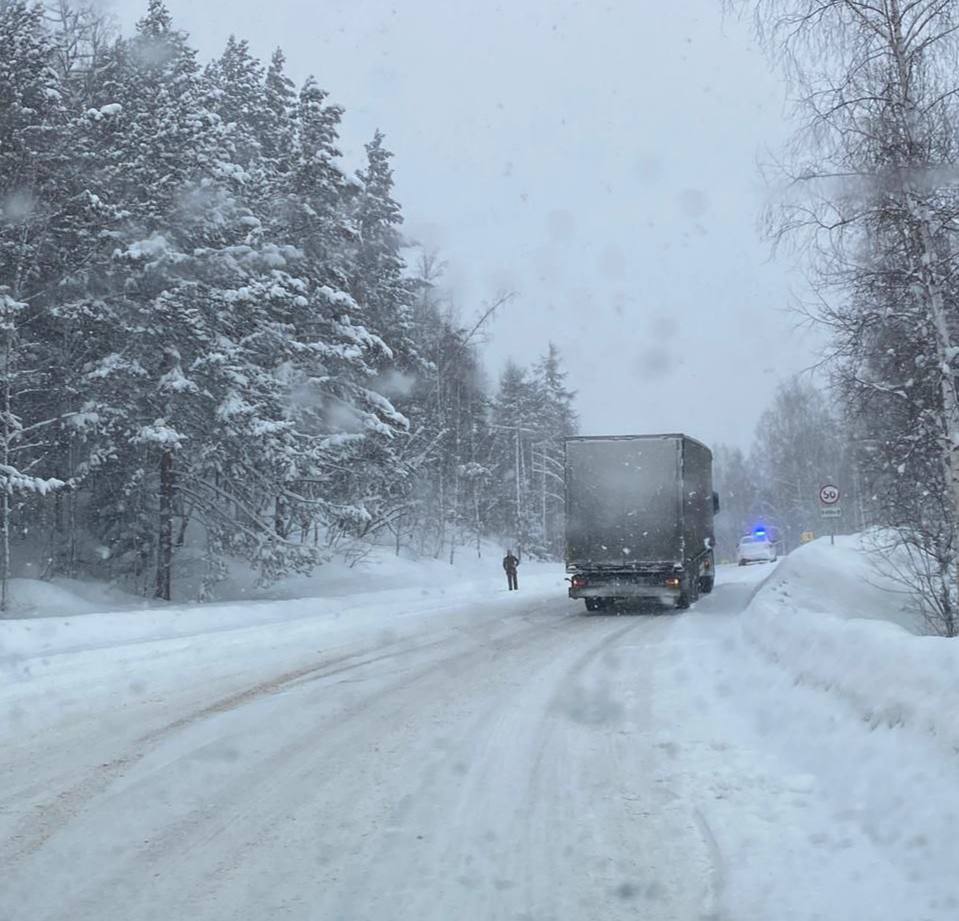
[0,0,576,601]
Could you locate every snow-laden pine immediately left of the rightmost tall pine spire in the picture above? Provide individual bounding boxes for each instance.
[275,78,407,552]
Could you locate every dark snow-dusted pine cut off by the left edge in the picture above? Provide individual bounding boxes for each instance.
[0,2,95,585]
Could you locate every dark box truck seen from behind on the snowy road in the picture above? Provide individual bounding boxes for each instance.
[566,435,719,611]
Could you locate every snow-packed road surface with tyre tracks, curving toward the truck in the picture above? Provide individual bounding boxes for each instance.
[0,566,959,921]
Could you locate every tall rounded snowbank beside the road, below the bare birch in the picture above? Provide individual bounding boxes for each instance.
[742,537,959,753]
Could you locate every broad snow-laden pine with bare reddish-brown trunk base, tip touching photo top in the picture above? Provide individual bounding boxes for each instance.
[61,2,312,598]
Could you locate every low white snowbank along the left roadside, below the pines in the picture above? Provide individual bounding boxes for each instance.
[0,551,565,671]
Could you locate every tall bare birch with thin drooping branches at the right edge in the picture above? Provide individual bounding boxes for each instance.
[752,0,959,632]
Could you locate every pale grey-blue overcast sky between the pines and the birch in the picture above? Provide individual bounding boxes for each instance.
[109,0,815,447]
